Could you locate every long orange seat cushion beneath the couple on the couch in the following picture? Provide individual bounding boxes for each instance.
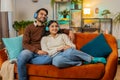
[15,63,105,79]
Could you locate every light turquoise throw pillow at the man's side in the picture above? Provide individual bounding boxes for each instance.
[2,36,23,60]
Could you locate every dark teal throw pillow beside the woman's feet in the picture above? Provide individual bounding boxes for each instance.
[80,34,112,57]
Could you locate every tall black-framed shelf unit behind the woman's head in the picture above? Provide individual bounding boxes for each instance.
[53,0,83,32]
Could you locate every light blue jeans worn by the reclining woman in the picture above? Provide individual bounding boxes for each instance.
[52,48,92,68]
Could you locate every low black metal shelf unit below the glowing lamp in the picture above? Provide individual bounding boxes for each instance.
[82,18,112,34]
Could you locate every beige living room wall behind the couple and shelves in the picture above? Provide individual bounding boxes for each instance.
[13,0,120,38]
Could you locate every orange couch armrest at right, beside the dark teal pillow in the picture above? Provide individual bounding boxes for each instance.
[102,39,118,80]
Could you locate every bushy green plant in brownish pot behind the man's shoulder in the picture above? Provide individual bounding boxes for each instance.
[13,20,33,35]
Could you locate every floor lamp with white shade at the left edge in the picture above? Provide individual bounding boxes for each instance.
[0,0,13,37]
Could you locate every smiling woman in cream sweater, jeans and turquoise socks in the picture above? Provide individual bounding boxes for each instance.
[41,20,106,68]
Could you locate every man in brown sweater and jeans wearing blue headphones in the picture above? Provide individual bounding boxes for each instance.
[17,8,74,80]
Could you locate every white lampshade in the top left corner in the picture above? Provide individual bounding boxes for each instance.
[0,0,13,12]
